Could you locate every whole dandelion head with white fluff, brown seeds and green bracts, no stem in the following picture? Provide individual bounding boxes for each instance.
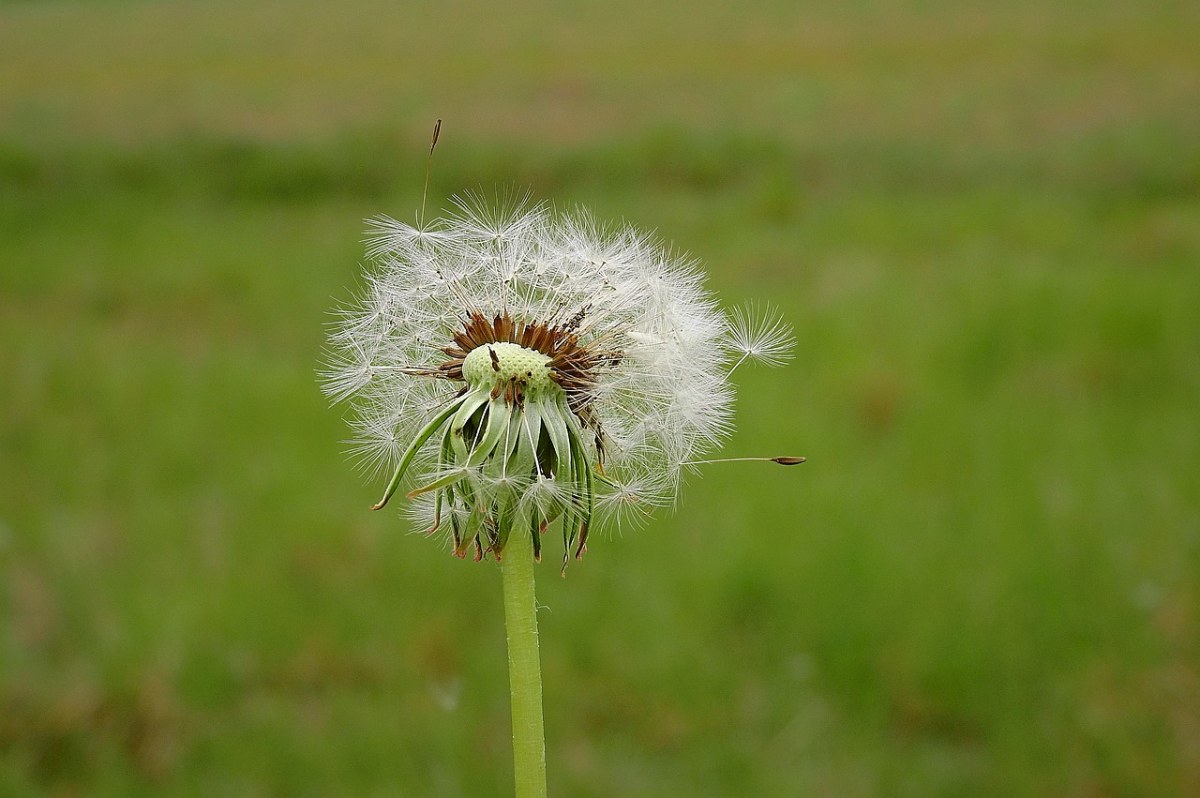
[324,197,802,569]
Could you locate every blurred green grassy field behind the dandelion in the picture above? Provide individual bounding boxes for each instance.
[0,0,1200,797]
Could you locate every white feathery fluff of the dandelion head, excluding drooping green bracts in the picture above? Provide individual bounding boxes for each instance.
[323,198,791,547]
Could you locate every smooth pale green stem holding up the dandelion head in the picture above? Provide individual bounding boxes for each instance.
[500,529,546,798]
